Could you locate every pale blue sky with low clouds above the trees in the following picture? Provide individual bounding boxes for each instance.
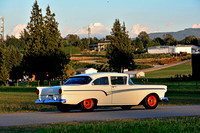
[0,0,200,38]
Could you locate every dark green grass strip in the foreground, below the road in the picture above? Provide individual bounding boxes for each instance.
[0,116,200,133]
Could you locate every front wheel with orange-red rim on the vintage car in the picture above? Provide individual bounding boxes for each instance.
[143,94,158,109]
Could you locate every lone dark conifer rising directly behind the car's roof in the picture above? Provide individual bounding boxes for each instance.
[106,19,134,72]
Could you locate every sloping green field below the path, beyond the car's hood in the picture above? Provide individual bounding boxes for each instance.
[145,62,192,78]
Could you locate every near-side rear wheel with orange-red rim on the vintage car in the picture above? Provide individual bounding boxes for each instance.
[80,99,97,112]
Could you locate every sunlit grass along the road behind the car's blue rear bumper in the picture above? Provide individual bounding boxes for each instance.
[0,91,57,113]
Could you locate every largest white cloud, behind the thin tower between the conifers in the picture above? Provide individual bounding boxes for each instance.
[74,23,111,38]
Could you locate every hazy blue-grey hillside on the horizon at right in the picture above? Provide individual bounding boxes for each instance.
[149,28,200,41]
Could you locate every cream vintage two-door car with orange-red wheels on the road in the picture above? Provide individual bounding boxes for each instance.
[35,73,168,112]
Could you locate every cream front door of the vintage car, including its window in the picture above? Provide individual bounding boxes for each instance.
[110,76,133,105]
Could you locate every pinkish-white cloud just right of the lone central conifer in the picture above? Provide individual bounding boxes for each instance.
[129,24,152,38]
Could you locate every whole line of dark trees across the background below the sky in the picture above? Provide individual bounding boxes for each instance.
[0,1,200,84]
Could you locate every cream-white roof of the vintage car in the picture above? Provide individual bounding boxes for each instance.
[73,72,128,78]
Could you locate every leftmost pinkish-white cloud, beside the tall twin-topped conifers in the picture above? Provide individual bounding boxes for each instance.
[8,24,27,38]
